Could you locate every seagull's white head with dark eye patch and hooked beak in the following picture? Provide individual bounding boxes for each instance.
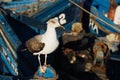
[47,18,64,29]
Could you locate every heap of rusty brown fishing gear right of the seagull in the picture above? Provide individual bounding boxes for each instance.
[62,23,120,80]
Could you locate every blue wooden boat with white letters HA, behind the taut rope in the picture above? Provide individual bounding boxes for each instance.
[86,0,120,61]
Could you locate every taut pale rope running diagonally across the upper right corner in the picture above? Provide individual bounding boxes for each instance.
[69,0,120,32]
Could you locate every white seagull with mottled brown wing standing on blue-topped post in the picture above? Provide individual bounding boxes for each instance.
[26,18,64,73]
